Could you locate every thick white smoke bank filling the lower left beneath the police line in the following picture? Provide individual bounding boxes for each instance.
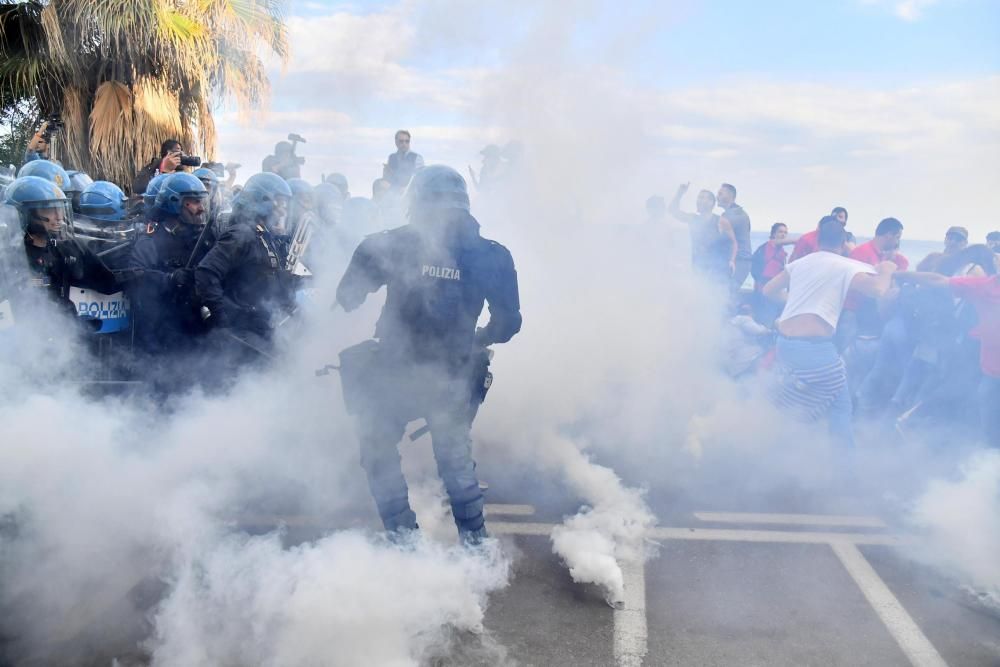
[0,270,509,665]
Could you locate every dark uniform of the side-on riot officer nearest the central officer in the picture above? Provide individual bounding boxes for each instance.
[195,219,296,340]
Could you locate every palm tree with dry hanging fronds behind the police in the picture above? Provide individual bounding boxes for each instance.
[0,0,288,187]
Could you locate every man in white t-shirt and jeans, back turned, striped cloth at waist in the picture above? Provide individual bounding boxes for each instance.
[763,216,896,446]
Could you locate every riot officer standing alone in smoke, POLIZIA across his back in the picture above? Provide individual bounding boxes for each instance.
[337,166,521,544]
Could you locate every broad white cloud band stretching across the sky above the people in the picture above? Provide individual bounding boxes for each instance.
[220,2,1000,238]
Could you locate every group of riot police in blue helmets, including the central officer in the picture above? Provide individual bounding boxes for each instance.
[0,130,521,545]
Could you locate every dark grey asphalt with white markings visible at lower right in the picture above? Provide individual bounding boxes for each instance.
[466,490,1000,667]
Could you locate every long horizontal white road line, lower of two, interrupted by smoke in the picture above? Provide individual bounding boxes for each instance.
[488,521,905,546]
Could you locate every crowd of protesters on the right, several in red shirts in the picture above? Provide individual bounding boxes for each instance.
[660,184,1000,447]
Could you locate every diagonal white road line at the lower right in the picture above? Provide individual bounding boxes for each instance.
[830,541,948,667]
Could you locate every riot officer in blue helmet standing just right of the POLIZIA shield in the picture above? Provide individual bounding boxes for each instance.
[128,172,214,352]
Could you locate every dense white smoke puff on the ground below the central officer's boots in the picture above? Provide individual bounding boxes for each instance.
[149,531,507,667]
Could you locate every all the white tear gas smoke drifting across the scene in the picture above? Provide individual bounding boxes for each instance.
[0,4,998,665]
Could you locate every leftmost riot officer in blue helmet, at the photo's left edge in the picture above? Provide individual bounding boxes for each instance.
[4,176,116,315]
